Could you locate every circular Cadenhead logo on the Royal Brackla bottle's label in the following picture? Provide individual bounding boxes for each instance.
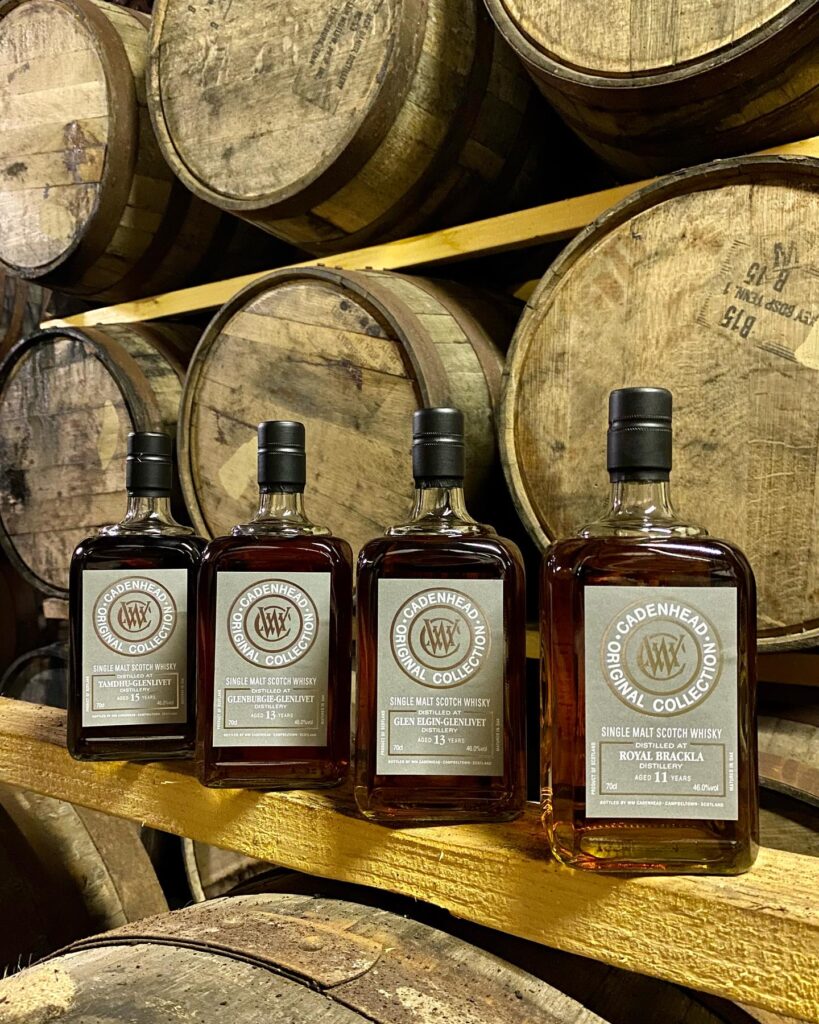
[601,600,723,717]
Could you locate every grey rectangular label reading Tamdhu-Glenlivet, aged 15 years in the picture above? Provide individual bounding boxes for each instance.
[82,568,188,726]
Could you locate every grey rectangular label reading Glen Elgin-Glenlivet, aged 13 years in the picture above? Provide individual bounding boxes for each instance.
[376,579,506,775]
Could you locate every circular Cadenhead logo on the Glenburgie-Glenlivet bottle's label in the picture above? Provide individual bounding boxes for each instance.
[227,580,318,668]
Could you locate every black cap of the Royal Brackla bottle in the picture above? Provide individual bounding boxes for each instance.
[607,387,672,480]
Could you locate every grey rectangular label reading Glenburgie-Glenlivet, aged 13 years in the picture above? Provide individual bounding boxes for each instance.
[213,572,330,746]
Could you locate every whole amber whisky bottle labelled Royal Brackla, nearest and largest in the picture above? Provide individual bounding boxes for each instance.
[542,388,758,874]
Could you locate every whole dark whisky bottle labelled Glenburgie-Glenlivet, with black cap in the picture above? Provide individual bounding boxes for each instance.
[197,420,352,790]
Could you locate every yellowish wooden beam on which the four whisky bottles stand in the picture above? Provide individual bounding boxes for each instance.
[0,698,819,1022]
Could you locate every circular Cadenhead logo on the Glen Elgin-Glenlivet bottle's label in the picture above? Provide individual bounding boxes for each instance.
[390,588,490,687]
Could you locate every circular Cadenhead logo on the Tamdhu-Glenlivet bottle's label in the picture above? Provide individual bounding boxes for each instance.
[94,577,177,657]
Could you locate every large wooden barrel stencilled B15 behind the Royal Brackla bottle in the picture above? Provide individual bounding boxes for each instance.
[501,158,819,648]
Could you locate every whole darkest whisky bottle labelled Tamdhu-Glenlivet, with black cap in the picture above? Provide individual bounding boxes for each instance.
[68,433,205,761]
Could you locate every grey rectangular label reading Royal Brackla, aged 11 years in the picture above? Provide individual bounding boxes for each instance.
[585,587,739,821]
